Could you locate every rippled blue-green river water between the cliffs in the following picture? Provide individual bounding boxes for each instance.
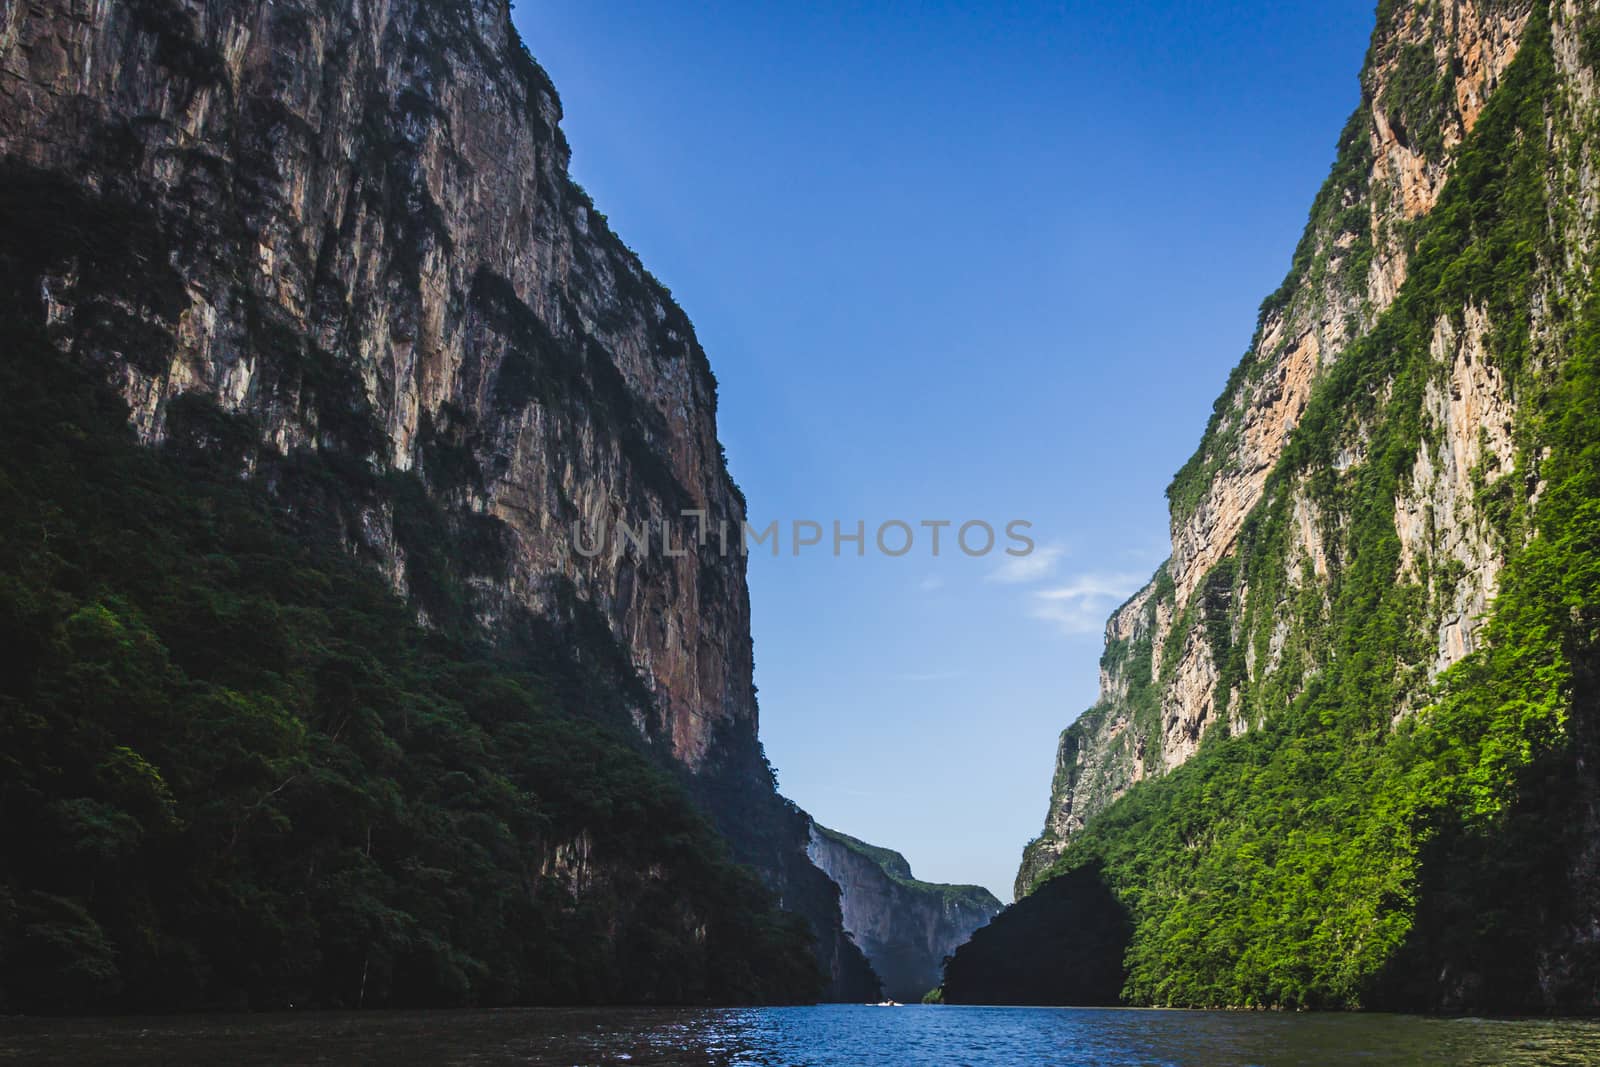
[0,1005,1600,1067]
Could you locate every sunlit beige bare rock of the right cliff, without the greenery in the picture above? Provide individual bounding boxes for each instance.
[1016,0,1568,897]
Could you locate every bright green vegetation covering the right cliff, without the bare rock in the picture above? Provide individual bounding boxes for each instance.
[998,8,1600,1011]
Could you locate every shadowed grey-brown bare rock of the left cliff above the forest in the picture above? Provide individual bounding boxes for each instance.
[0,0,870,992]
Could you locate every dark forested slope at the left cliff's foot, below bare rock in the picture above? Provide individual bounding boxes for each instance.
[0,337,821,1011]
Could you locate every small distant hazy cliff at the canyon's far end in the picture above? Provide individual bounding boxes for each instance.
[808,824,1000,1003]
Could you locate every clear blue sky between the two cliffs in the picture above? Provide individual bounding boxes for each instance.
[515,0,1371,901]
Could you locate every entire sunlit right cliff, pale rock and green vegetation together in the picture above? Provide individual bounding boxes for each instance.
[992,0,1600,1011]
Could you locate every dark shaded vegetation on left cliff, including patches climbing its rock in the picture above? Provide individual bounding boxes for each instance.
[0,0,877,1011]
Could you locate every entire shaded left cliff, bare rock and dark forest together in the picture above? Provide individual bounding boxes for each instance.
[0,0,902,1011]
